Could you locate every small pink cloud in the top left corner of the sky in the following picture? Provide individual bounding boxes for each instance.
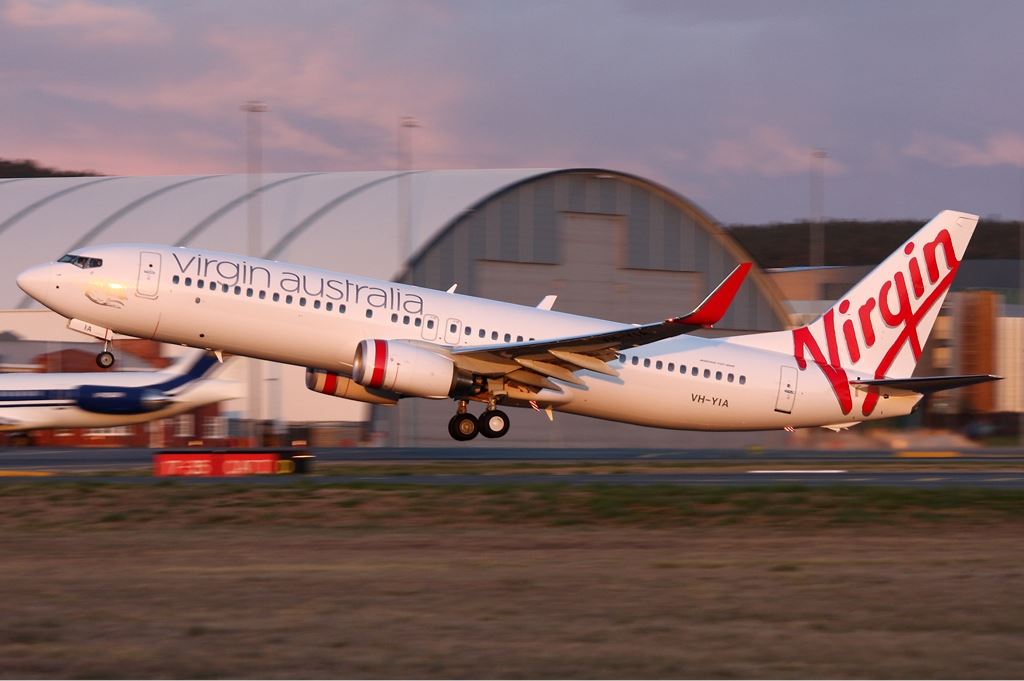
[2,0,169,44]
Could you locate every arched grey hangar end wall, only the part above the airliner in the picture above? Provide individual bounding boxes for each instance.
[400,168,788,331]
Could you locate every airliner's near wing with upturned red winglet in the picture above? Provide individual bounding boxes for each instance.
[452,262,751,388]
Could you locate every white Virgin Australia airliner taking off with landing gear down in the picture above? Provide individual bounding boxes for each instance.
[17,211,996,440]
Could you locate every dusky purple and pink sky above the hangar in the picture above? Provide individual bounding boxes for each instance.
[0,0,1024,223]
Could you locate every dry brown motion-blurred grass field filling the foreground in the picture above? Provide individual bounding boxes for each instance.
[0,480,1024,678]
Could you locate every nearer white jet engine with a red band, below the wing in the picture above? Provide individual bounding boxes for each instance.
[352,340,472,397]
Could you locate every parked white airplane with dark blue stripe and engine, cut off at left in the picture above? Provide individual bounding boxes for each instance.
[0,350,241,432]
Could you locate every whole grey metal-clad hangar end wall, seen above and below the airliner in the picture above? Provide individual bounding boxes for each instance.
[374,170,787,446]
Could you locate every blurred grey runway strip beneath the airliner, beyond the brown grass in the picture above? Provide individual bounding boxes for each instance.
[6,448,1024,488]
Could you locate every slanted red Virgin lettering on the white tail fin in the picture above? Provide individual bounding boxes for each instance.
[793,228,961,416]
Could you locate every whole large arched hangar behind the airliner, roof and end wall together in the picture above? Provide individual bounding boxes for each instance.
[0,169,788,446]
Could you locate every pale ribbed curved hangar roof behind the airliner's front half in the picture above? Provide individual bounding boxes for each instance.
[0,169,545,307]
